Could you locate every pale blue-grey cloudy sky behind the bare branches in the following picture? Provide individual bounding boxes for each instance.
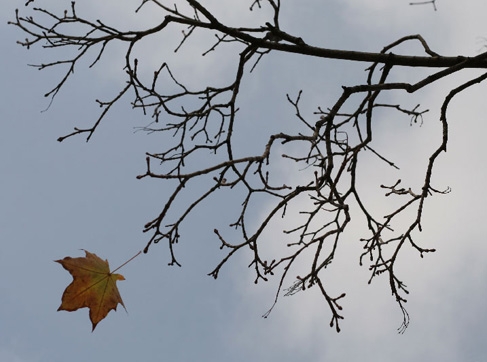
[0,0,487,362]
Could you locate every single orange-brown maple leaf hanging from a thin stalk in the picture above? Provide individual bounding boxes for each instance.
[55,250,125,331]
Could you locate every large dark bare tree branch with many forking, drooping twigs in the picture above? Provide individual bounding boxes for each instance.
[10,0,487,332]
